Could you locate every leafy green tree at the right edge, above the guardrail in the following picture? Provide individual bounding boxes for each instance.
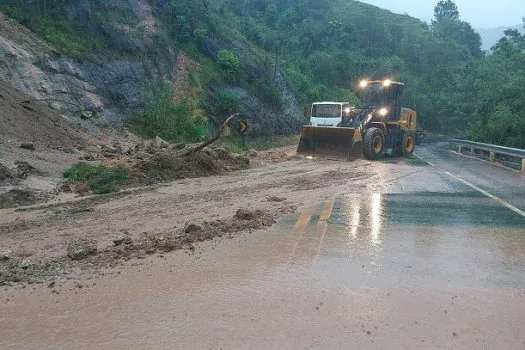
[456,22,525,149]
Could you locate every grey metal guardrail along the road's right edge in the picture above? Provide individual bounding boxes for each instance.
[449,139,525,172]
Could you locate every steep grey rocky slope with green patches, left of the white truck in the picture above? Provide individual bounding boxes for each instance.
[0,0,302,136]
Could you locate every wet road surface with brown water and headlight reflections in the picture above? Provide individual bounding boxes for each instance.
[0,145,525,349]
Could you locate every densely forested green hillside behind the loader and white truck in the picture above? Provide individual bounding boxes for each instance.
[216,0,525,147]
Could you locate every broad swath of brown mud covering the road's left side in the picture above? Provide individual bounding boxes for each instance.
[0,149,369,285]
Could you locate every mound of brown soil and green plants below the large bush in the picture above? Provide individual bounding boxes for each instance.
[60,137,250,195]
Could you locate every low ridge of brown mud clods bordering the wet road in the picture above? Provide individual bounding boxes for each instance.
[0,209,282,285]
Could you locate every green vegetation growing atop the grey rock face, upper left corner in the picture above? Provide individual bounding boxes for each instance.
[0,0,140,61]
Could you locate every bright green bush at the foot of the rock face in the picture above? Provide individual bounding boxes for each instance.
[128,86,208,142]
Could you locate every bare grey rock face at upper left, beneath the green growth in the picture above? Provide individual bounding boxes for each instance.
[0,9,177,124]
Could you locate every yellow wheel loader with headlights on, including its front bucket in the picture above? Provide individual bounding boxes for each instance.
[297,80,417,160]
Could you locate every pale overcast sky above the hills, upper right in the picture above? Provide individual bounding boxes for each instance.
[361,0,525,28]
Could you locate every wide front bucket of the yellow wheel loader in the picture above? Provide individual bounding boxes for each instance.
[297,126,362,158]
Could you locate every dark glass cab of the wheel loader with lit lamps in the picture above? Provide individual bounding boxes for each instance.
[357,79,405,121]
